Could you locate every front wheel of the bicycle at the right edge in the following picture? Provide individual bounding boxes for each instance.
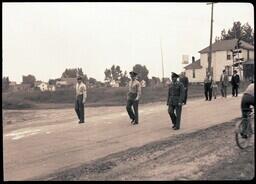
[235,121,251,149]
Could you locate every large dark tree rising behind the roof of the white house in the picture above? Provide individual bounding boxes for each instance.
[215,21,254,45]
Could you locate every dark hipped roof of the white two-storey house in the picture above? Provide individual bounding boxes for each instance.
[199,39,254,54]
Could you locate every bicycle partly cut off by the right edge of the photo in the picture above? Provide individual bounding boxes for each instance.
[235,108,254,149]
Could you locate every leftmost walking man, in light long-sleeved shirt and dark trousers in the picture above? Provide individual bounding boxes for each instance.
[75,76,87,123]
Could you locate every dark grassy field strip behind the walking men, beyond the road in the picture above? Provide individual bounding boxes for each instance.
[2,83,249,109]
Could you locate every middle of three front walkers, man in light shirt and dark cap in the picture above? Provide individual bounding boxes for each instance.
[126,72,141,125]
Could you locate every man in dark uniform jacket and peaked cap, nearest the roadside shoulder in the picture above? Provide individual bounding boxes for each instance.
[167,72,185,130]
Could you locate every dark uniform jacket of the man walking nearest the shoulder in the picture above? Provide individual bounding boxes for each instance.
[167,81,185,105]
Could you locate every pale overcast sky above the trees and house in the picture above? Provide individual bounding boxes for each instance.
[2,3,254,82]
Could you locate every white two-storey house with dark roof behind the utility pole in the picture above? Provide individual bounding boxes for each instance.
[184,39,254,82]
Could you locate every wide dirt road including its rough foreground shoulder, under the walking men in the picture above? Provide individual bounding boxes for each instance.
[3,97,254,181]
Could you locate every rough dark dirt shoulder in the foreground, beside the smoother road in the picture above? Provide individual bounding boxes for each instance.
[40,121,255,181]
